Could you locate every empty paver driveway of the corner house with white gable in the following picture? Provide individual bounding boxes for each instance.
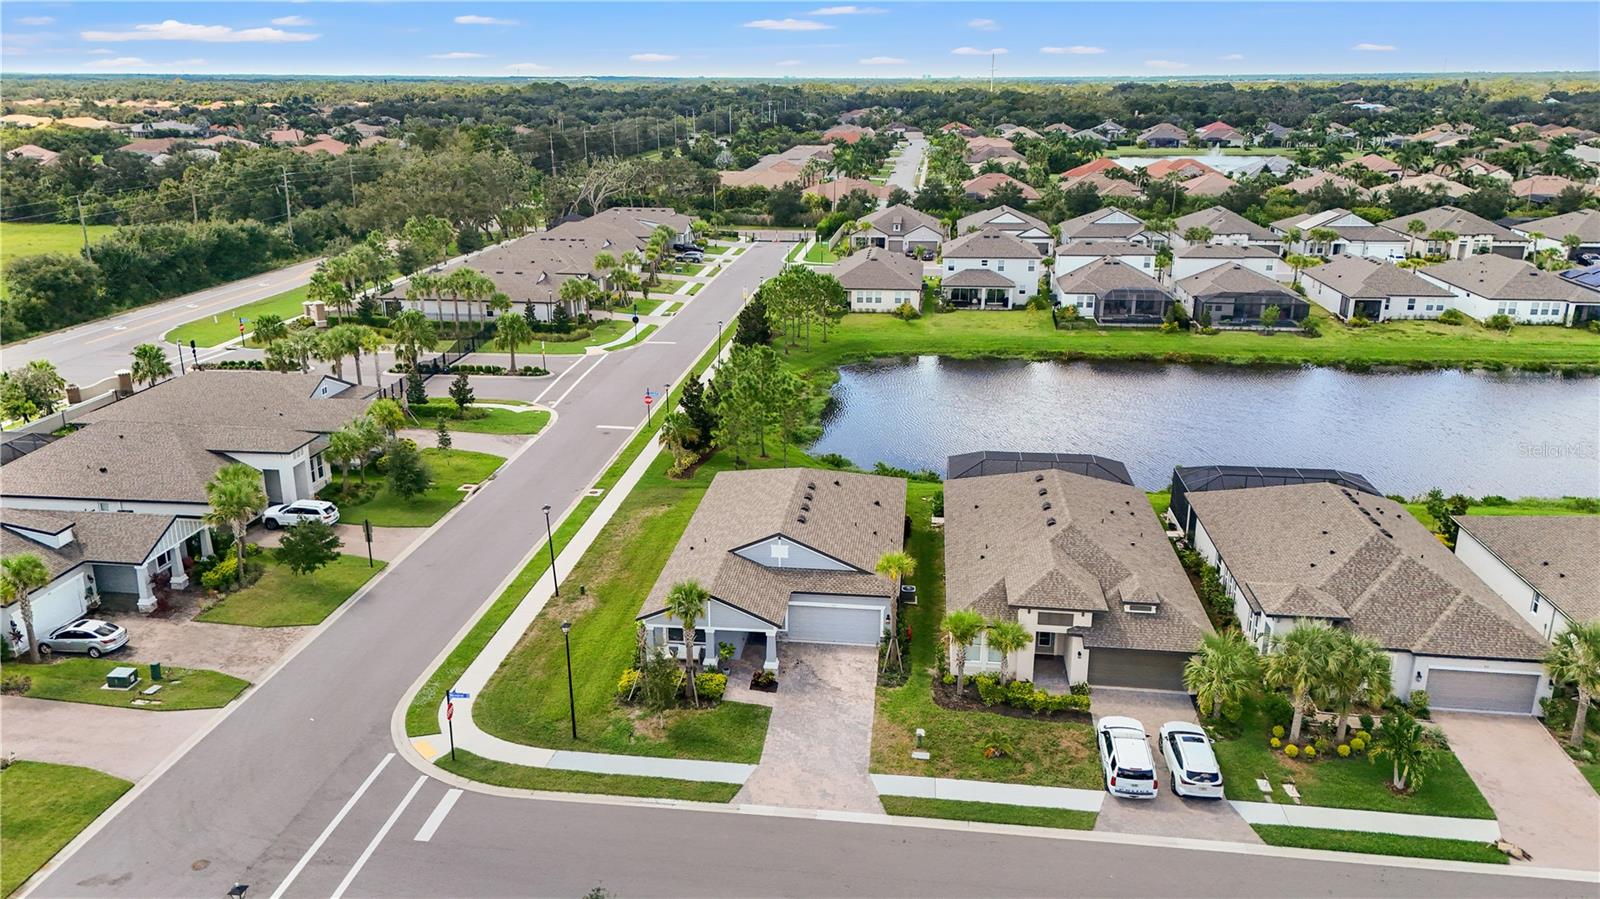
[733,643,883,813]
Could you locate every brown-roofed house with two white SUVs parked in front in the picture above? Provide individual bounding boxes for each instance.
[944,454,1211,691]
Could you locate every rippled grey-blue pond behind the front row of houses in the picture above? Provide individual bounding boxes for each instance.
[811,357,1600,497]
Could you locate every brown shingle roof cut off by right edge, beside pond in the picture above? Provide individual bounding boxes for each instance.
[1456,515,1600,621]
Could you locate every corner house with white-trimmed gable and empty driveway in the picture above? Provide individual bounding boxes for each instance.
[638,469,906,670]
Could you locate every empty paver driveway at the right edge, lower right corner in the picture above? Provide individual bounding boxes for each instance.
[1434,712,1600,870]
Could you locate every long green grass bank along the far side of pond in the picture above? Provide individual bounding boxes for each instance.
[790,310,1600,370]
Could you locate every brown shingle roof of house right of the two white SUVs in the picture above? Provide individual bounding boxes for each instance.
[1189,483,1544,659]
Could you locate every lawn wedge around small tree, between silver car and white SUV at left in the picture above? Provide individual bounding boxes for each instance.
[195,545,386,627]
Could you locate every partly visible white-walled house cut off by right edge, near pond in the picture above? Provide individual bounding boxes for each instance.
[1454,515,1600,640]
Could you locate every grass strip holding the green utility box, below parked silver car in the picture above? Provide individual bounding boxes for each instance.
[3,656,250,712]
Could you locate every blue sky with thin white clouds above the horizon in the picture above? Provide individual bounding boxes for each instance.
[0,0,1600,78]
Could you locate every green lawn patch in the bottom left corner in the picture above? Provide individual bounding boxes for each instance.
[0,761,133,896]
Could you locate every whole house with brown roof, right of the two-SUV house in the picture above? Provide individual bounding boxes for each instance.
[1187,483,1550,715]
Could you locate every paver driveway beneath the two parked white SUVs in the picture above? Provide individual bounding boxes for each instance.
[1093,686,1261,843]
